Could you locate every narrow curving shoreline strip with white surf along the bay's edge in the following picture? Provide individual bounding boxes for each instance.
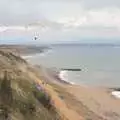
[21,52,120,91]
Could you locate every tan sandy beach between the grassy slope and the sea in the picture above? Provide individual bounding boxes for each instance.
[36,65,120,120]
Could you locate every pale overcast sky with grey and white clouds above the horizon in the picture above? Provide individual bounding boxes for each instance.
[0,0,120,43]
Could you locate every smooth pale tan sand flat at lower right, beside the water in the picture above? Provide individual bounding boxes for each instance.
[67,86,120,120]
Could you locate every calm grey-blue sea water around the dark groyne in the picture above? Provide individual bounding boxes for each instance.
[29,45,120,87]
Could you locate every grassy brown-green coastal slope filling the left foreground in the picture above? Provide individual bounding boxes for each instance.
[0,51,61,120]
